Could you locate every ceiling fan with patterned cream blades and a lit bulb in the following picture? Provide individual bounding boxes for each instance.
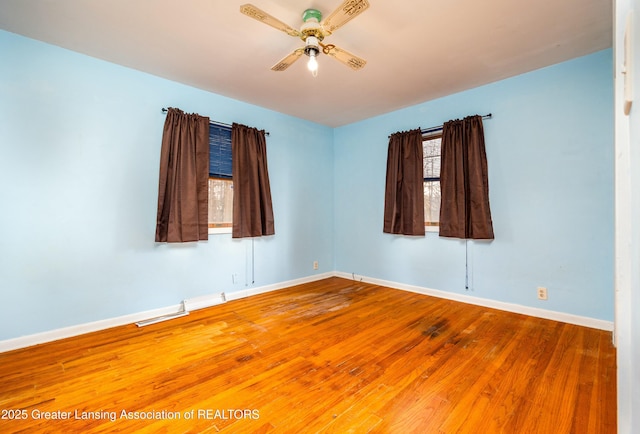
[240,0,369,77]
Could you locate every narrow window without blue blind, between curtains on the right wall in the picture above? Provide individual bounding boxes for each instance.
[422,130,442,232]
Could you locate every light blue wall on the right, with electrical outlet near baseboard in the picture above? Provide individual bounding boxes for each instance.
[334,50,614,321]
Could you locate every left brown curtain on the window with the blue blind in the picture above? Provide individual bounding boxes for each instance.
[156,108,209,243]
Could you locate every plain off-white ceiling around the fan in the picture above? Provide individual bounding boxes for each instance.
[0,0,612,127]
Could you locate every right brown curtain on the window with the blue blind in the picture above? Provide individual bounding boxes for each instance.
[231,123,275,238]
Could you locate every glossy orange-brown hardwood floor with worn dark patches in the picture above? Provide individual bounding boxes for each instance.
[0,278,616,434]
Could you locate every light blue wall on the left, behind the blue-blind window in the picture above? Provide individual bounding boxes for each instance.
[0,31,334,340]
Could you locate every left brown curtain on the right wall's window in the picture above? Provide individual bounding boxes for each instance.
[383,129,425,236]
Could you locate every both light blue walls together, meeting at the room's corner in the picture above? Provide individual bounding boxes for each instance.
[0,31,613,340]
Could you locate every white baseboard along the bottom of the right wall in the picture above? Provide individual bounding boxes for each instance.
[334,272,613,331]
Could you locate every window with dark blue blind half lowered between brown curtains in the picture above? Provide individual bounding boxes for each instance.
[209,124,233,234]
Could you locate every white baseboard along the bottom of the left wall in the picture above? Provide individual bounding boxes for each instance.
[0,272,334,353]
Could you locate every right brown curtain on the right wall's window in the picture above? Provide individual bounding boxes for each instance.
[440,115,493,239]
